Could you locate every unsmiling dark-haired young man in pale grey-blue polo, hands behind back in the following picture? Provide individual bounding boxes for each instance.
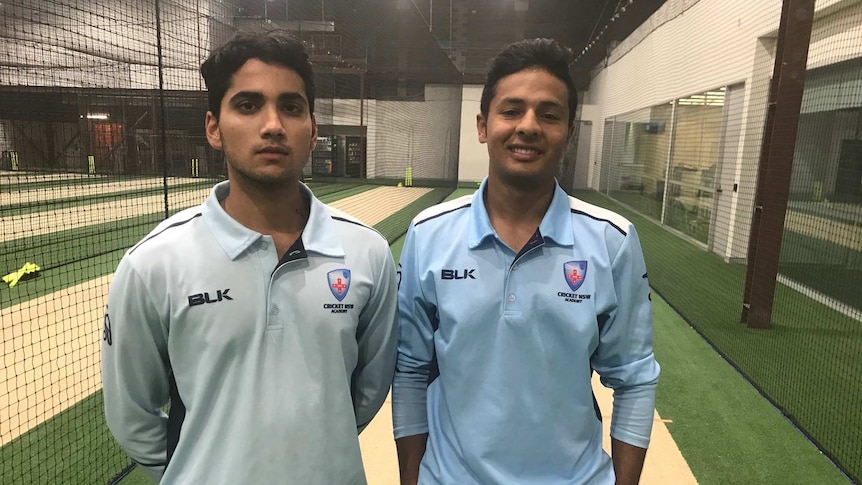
[102,32,397,485]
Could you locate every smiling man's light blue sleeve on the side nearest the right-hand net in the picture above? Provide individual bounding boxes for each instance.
[592,226,660,448]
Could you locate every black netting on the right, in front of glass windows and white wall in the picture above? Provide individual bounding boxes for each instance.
[588,0,862,480]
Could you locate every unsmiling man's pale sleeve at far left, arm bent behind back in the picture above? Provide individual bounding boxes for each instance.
[102,258,170,481]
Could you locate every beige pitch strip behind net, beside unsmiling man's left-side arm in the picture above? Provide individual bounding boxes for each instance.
[0,276,110,446]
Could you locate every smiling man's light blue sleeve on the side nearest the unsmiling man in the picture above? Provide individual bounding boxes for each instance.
[392,225,436,439]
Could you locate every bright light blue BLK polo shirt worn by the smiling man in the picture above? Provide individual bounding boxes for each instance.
[392,181,659,485]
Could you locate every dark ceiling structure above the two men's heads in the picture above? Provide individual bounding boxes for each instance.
[239,0,665,89]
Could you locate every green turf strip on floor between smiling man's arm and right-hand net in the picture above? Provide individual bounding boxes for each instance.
[652,294,848,485]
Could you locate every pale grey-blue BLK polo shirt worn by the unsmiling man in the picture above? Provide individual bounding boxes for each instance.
[102,182,397,485]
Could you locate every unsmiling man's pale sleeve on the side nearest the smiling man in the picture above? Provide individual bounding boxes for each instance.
[352,242,398,432]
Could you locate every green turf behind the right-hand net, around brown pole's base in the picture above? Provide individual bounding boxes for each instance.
[575,191,862,478]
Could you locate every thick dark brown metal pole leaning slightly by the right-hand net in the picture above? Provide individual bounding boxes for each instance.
[742,0,815,328]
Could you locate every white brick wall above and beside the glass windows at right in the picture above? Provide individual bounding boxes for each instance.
[584,0,862,260]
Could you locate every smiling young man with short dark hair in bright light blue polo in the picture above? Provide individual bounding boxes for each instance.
[392,39,659,485]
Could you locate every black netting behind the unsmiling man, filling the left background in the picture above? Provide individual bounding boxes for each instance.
[0,0,461,484]
